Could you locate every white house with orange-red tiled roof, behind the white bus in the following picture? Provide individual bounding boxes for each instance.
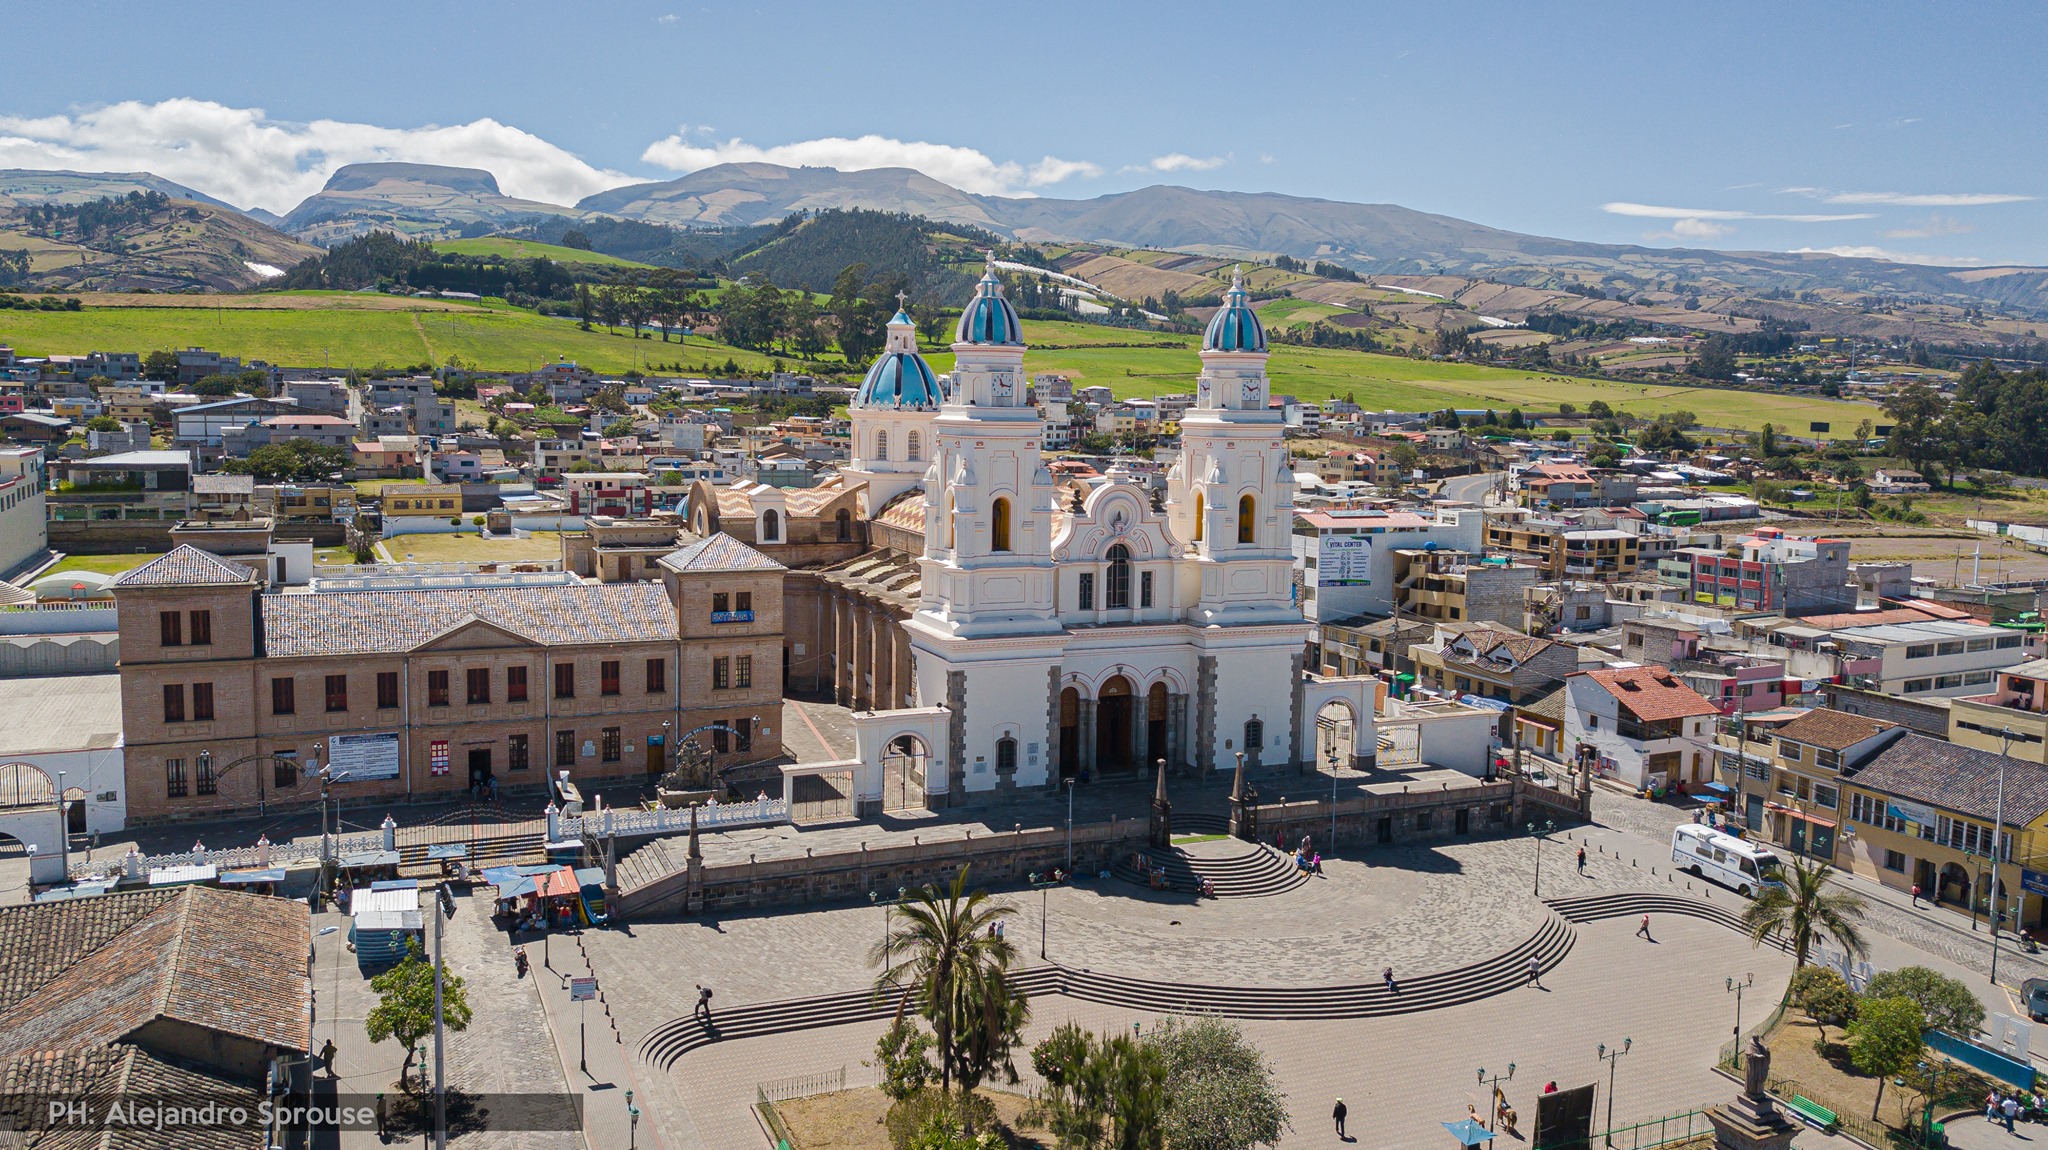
[1565,667,1720,788]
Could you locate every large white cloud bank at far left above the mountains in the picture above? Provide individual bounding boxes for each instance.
[0,98,633,213]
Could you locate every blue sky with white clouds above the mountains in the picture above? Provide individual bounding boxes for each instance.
[0,0,2048,264]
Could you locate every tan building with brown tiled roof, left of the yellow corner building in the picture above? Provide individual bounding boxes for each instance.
[1735,706,1909,864]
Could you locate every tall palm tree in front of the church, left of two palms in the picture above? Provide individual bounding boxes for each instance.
[868,866,1026,1091]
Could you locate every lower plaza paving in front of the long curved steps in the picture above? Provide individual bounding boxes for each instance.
[664,919,1790,1150]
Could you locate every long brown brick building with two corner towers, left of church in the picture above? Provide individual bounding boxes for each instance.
[113,536,784,821]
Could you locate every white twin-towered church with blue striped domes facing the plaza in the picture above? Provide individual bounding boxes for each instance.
[795,266,1374,812]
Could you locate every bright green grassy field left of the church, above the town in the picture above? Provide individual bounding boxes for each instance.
[0,295,772,372]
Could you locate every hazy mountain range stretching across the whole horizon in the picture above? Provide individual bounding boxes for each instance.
[0,164,2048,315]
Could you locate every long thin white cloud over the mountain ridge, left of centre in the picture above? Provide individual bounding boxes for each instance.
[641,133,1102,196]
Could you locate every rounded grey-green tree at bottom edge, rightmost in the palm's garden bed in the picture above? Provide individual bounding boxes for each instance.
[1149,1019,1288,1150]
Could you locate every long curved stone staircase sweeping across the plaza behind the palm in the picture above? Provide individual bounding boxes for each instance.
[639,917,1575,1070]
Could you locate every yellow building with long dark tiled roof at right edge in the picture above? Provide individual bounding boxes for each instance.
[1837,735,2048,929]
